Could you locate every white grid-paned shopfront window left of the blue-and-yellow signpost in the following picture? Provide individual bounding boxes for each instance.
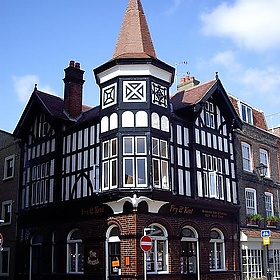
[242,249,263,280]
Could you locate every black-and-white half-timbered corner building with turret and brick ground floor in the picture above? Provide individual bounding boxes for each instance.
[14,0,241,280]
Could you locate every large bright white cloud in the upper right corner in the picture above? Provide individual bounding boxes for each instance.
[200,0,280,51]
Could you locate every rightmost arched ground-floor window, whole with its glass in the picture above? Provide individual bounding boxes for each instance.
[209,229,225,270]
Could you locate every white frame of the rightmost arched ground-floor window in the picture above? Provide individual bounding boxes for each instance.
[209,228,226,271]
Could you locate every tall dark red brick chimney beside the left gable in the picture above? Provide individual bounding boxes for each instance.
[63,60,85,119]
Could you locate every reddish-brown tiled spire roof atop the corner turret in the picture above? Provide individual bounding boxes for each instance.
[113,0,156,59]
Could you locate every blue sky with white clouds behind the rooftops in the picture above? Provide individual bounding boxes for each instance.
[0,0,280,132]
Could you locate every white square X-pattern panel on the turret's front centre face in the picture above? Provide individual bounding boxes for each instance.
[123,81,146,102]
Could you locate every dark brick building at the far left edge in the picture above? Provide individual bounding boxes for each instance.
[0,130,20,279]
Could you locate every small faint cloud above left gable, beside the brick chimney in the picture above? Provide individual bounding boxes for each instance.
[13,74,56,103]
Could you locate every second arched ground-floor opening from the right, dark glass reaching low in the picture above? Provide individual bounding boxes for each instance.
[181,227,199,279]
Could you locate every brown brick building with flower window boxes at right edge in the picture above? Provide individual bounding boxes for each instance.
[230,96,280,279]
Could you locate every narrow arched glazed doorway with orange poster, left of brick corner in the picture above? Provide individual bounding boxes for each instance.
[106,225,121,279]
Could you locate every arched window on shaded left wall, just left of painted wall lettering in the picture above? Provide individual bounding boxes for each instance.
[67,229,84,273]
